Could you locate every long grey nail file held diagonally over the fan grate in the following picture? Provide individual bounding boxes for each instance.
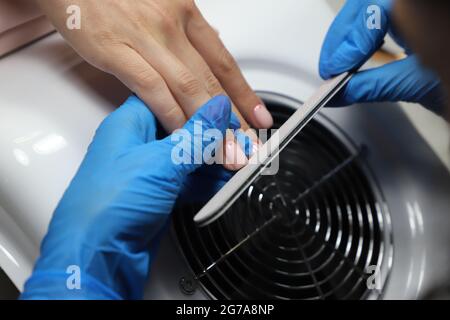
[194,72,352,227]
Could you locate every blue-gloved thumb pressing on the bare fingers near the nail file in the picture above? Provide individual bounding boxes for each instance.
[163,96,231,176]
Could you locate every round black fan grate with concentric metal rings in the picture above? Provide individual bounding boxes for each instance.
[174,93,392,299]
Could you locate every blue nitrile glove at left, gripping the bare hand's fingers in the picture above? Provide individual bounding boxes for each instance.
[22,96,236,299]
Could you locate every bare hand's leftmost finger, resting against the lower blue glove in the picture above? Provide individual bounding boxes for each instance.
[107,46,187,132]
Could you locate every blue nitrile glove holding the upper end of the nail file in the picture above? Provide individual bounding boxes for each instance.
[319,0,445,114]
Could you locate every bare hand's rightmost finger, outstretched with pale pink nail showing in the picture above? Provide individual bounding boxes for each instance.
[186,8,273,128]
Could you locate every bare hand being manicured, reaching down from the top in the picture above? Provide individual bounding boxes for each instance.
[39,0,272,132]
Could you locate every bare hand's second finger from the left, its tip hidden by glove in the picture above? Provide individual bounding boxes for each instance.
[136,36,211,118]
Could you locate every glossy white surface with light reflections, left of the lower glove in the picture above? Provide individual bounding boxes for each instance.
[0,34,128,288]
